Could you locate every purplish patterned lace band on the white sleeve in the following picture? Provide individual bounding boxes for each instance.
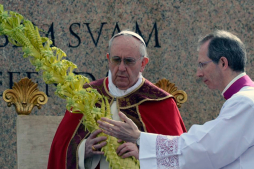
[156,135,179,169]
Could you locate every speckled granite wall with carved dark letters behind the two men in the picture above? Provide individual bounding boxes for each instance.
[0,0,254,169]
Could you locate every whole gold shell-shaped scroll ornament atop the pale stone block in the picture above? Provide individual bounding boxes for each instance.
[3,77,48,115]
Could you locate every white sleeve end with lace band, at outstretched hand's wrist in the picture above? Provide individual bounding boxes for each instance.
[139,132,181,169]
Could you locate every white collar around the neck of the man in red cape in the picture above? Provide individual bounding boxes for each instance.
[108,70,143,97]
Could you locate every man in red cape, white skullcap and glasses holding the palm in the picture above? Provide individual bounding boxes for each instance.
[48,31,186,169]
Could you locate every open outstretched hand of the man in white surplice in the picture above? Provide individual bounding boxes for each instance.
[98,112,140,144]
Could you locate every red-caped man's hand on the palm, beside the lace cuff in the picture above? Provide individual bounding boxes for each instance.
[116,140,139,159]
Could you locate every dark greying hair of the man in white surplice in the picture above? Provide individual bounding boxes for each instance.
[198,30,247,72]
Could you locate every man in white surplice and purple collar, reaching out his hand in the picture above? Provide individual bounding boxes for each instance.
[99,31,254,169]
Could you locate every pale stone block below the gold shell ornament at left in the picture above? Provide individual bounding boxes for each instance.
[17,115,63,169]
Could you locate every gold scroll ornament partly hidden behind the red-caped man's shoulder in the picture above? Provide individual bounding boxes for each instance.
[155,78,187,108]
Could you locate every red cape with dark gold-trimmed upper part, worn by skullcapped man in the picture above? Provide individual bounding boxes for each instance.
[48,78,186,169]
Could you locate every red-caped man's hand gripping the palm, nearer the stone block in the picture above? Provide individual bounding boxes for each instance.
[85,129,107,159]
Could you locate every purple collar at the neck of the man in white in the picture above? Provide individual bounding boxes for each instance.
[223,75,254,100]
